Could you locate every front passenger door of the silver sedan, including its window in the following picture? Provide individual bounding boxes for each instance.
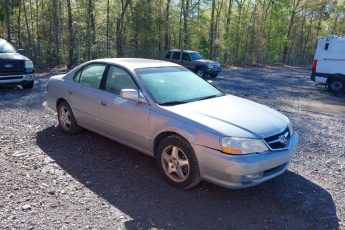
[99,65,150,150]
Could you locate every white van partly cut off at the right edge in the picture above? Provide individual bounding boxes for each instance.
[311,35,345,93]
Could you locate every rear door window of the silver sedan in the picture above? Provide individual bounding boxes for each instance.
[79,64,106,88]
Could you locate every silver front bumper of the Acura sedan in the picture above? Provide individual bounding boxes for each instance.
[193,133,299,189]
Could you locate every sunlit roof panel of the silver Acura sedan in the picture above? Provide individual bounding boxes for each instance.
[92,58,179,70]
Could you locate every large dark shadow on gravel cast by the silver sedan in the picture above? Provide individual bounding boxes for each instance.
[36,126,339,229]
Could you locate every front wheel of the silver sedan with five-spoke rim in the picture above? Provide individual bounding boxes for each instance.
[156,136,201,189]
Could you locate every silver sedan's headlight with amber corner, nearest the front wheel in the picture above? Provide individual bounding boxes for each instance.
[222,137,268,154]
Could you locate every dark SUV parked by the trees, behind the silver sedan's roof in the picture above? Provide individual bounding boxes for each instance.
[164,49,221,78]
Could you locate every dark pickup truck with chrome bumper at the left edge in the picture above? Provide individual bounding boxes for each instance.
[0,38,35,89]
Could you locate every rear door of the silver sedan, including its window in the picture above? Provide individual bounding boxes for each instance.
[68,63,107,130]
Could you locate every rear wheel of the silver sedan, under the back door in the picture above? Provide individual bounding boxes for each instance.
[57,101,82,134]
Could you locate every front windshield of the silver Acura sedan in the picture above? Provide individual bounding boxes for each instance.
[136,67,224,105]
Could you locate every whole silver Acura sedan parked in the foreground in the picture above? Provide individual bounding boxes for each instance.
[45,58,299,189]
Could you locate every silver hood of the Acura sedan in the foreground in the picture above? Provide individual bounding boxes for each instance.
[164,95,289,138]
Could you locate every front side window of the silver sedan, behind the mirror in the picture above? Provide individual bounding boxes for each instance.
[105,66,138,95]
